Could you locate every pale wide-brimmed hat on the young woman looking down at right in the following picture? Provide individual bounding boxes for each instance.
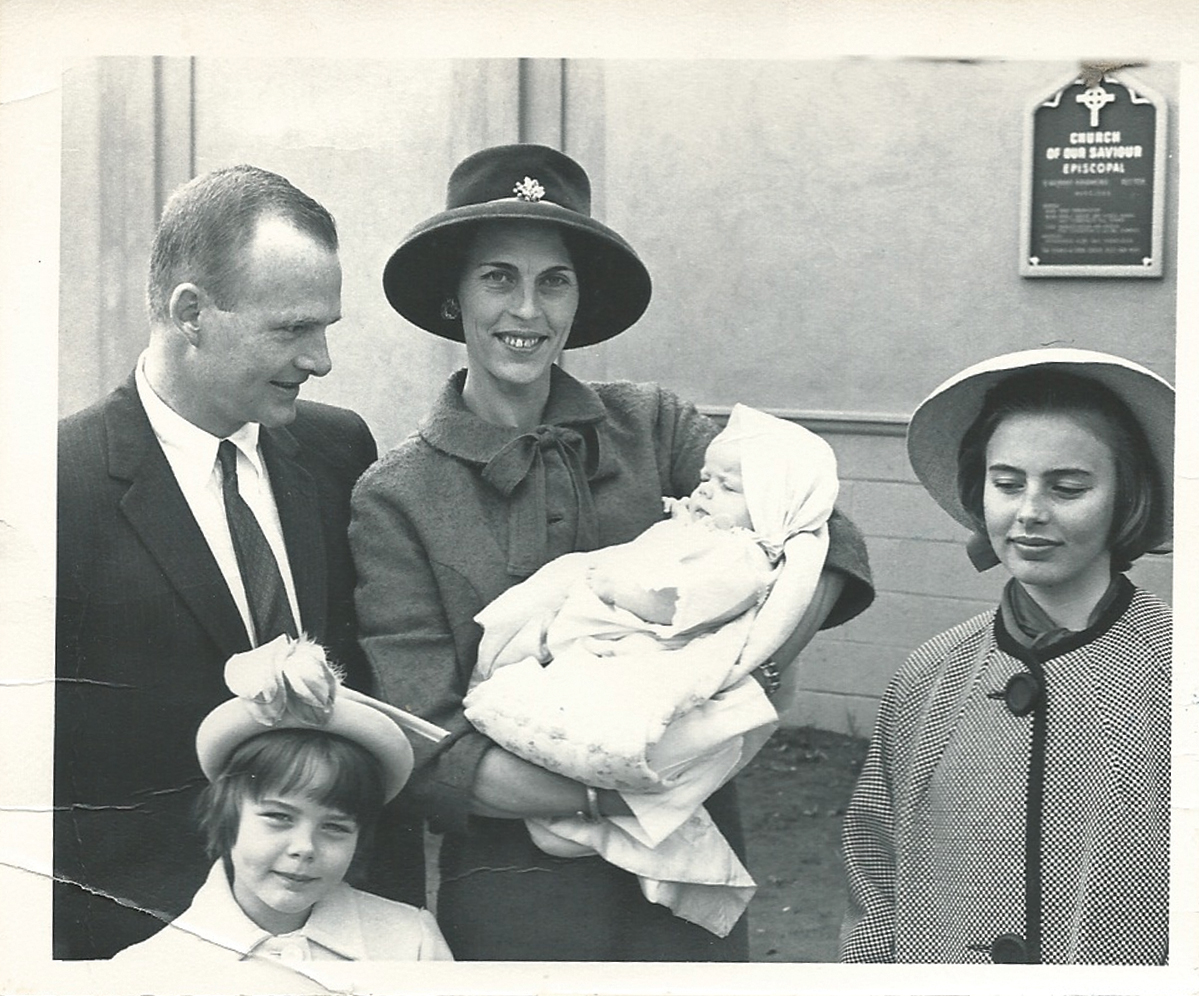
[908,349,1174,550]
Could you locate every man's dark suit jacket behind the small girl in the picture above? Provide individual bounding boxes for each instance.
[54,376,423,958]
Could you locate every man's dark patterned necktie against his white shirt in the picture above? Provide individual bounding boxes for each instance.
[217,439,297,646]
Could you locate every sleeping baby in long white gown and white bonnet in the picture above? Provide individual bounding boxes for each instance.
[465,405,837,934]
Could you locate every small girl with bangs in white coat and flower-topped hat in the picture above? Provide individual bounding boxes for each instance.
[113,636,452,971]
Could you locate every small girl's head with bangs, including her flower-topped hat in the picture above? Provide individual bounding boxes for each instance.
[195,638,412,934]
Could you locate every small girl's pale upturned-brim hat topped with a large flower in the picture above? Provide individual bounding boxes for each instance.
[195,636,412,802]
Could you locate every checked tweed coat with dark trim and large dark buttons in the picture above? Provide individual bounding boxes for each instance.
[842,577,1171,964]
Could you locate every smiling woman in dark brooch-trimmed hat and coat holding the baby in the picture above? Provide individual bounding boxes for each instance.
[350,145,872,961]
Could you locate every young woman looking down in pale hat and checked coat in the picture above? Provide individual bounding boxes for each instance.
[842,349,1174,964]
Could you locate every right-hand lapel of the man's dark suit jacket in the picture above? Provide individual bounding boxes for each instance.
[259,428,329,640]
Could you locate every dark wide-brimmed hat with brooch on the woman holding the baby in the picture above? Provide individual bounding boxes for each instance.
[382,144,651,349]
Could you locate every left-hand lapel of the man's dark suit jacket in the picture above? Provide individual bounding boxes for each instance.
[104,375,249,654]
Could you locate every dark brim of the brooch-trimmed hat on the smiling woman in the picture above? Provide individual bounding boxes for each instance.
[382,198,652,349]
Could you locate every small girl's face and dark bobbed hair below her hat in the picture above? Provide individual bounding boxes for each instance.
[200,729,384,934]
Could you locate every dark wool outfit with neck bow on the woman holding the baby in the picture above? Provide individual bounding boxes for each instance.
[350,367,873,960]
